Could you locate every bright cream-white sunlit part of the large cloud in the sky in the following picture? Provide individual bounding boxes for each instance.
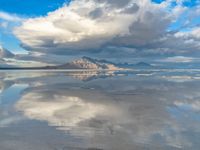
[15,1,136,50]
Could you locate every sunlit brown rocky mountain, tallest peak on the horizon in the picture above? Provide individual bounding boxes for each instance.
[56,57,122,70]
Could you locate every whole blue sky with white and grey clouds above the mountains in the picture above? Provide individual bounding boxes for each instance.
[0,0,200,64]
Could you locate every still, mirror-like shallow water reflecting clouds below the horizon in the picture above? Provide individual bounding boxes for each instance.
[0,70,200,150]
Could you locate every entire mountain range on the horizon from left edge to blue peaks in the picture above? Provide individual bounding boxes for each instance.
[0,46,152,70]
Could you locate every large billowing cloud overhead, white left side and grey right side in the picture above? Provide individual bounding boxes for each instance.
[14,0,172,53]
